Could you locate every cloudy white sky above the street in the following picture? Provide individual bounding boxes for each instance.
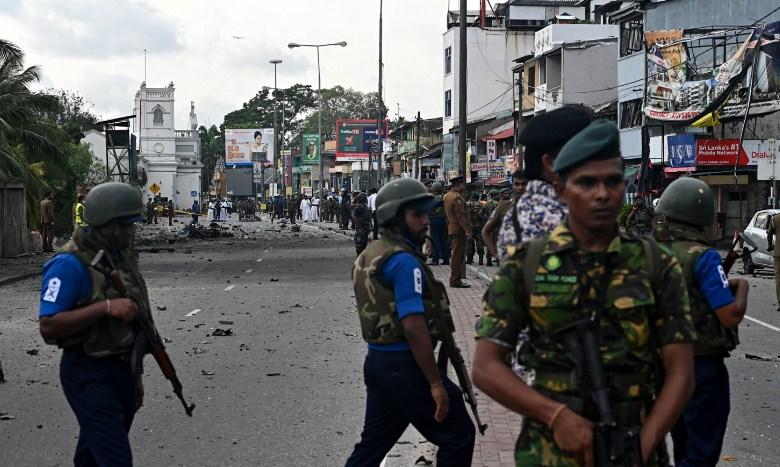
[0,0,479,128]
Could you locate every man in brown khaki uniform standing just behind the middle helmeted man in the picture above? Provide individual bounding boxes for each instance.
[443,177,472,289]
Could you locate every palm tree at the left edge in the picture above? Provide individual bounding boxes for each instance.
[0,39,58,224]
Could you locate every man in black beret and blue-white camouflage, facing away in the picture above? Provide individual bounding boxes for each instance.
[498,107,591,261]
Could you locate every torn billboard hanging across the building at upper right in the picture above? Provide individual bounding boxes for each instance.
[644,22,780,122]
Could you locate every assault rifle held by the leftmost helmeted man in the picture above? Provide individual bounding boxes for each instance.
[90,250,195,417]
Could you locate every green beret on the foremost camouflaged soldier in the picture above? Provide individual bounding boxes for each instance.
[553,120,620,173]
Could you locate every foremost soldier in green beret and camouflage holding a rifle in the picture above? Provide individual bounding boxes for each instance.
[473,120,696,466]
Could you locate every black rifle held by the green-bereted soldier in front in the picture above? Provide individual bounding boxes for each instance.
[556,318,644,467]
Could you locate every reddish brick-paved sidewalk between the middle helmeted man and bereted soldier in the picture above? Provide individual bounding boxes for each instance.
[431,266,521,467]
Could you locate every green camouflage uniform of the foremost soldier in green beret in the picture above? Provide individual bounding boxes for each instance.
[476,224,695,467]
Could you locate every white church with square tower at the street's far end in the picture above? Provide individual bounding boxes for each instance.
[133,82,203,209]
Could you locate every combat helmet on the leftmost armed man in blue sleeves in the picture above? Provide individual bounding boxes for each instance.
[84,182,144,227]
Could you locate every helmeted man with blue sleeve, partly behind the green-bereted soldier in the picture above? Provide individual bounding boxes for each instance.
[655,177,748,467]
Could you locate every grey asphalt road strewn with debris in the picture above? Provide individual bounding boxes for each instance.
[0,222,780,466]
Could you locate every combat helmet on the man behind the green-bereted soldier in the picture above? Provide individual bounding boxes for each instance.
[656,177,715,227]
